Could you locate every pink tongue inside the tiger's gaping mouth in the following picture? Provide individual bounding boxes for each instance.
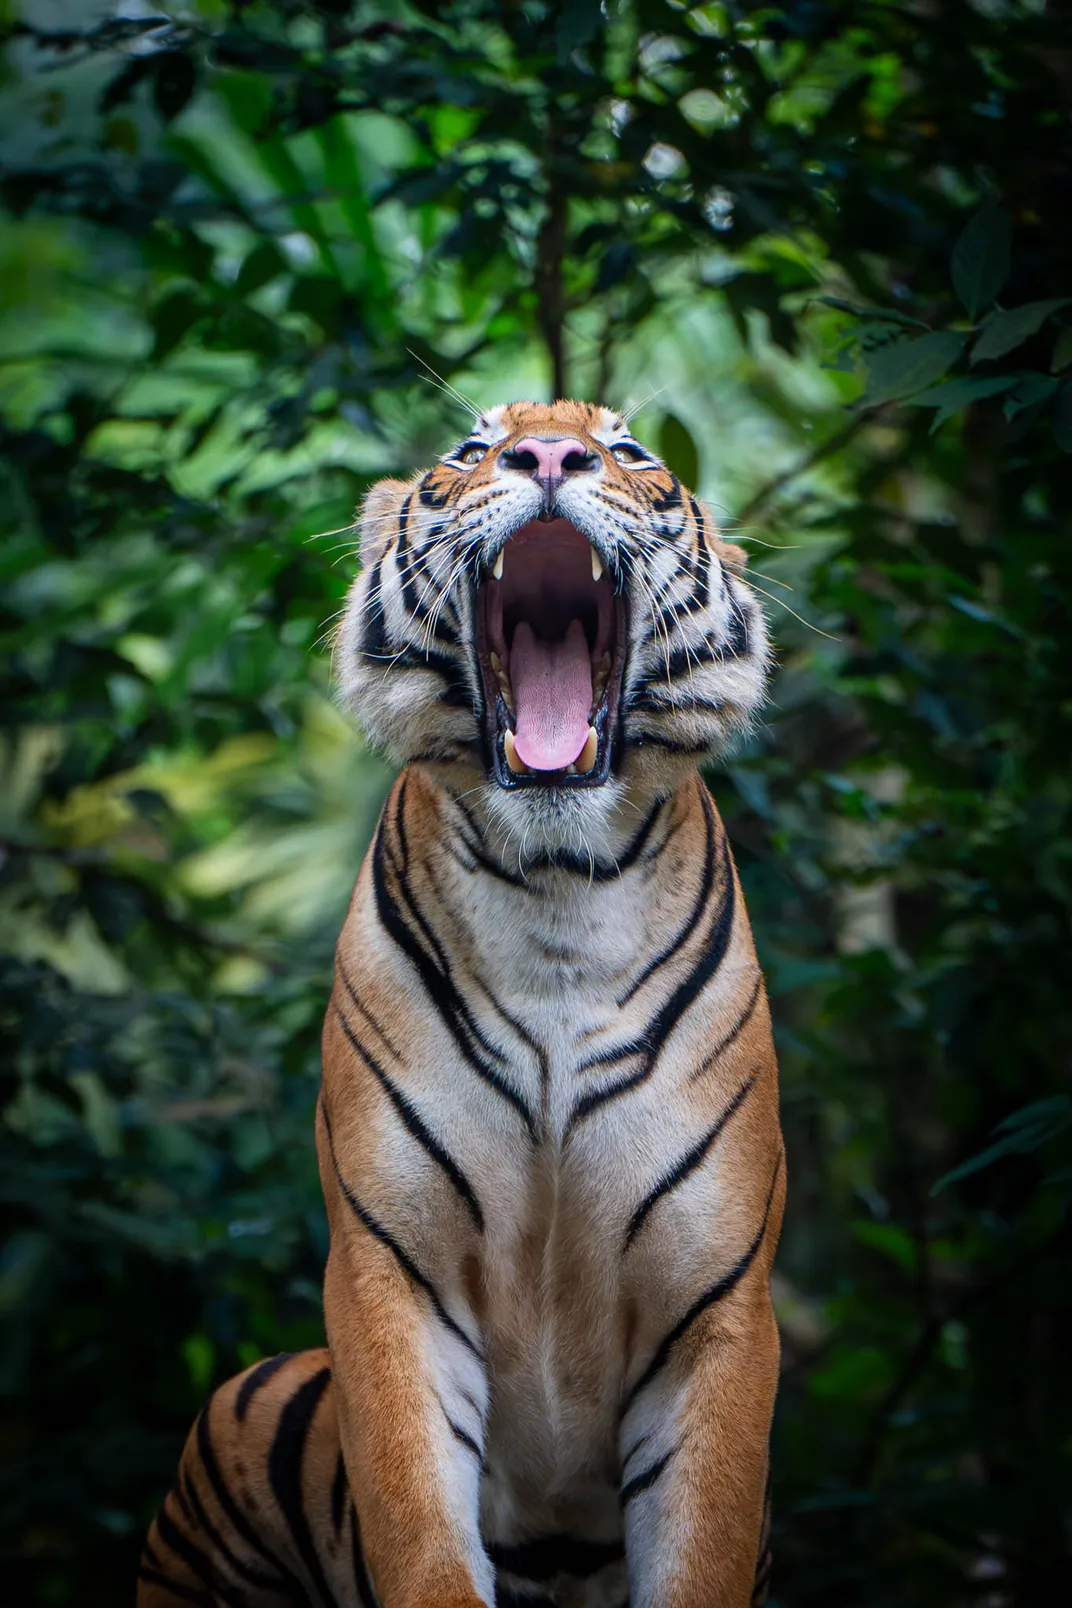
[509,619,591,770]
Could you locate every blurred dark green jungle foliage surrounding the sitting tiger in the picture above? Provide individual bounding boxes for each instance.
[0,0,1072,1608]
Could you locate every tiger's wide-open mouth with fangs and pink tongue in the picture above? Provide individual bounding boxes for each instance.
[476,519,627,788]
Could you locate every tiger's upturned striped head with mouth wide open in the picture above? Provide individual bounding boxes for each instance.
[336,402,768,852]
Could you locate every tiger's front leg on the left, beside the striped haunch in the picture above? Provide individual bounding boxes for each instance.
[318,1080,495,1608]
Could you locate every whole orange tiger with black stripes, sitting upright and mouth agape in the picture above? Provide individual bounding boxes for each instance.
[138,400,786,1608]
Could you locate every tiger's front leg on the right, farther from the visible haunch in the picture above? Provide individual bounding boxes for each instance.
[622,1155,784,1608]
